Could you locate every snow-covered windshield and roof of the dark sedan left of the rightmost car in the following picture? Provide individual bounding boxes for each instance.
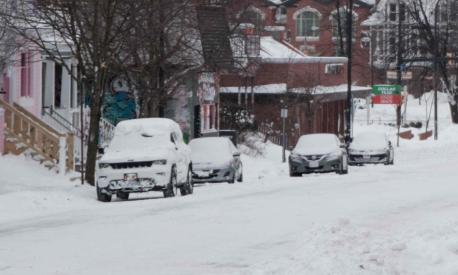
[293,134,339,155]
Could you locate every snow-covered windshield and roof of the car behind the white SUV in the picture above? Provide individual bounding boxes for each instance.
[189,137,232,162]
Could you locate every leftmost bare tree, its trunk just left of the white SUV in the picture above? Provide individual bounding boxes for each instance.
[0,0,131,184]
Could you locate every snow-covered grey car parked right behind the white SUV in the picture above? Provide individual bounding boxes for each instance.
[189,137,243,183]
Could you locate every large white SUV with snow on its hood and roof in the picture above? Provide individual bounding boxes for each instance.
[96,118,193,202]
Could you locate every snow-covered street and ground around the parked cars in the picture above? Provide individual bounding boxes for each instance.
[0,95,458,275]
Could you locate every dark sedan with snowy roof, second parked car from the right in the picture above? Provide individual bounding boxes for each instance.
[288,134,348,177]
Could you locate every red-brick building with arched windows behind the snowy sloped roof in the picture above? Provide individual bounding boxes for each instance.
[228,0,373,85]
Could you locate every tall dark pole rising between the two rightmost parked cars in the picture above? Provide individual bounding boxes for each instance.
[345,0,353,145]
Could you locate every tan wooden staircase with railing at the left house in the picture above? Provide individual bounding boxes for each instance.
[0,99,75,173]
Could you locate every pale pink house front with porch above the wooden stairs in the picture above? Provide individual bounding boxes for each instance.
[0,47,80,155]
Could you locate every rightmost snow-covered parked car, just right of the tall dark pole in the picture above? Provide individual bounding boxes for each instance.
[348,132,394,165]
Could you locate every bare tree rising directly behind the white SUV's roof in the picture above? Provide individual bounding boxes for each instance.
[118,0,202,117]
